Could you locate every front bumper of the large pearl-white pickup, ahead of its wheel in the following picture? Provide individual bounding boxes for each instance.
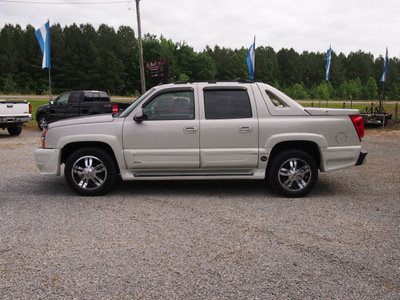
[34,147,61,176]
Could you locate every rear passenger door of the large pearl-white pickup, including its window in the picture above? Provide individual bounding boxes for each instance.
[200,87,259,170]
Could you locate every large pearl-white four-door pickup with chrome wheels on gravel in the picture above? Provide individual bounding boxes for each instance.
[35,82,367,197]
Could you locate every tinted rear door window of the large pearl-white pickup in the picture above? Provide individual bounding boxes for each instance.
[204,90,252,119]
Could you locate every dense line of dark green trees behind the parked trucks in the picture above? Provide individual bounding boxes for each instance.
[0,24,400,100]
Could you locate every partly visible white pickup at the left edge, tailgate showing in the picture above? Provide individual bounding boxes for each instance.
[0,100,32,135]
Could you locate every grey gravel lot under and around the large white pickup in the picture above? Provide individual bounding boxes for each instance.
[0,129,400,299]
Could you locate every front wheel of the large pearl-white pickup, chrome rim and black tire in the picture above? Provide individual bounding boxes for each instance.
[64,148,117,196]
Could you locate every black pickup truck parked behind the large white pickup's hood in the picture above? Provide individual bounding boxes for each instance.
[36,91,131,130]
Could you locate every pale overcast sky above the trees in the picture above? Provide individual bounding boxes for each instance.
[0,0,400,58]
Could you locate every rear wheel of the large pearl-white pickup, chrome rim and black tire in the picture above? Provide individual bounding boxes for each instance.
[267,149,318,197]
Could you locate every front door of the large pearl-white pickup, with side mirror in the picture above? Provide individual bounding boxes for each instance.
[123,88,199,170]
